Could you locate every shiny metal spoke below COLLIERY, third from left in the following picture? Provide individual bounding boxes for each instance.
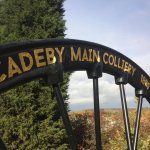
[119,84,132,150]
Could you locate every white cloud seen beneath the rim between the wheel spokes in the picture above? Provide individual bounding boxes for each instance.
[69,71,139,110]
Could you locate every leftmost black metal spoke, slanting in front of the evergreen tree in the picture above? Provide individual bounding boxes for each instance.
[53,84,78,150]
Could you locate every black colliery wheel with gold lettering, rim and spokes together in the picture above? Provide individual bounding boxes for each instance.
[0,39,150,150]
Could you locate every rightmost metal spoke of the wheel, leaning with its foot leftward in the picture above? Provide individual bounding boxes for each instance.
[133,95,143,150]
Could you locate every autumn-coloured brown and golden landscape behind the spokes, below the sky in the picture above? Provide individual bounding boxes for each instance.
[69,108,150,150]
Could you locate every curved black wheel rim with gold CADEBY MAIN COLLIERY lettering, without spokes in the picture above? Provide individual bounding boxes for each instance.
[0,39,150,102]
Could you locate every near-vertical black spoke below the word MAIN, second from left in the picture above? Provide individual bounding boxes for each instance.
[93,78,102,150]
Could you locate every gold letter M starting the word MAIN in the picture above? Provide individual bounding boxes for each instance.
[71,47,81,61]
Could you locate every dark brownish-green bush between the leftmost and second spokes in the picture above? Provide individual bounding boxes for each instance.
[70,112,96,150]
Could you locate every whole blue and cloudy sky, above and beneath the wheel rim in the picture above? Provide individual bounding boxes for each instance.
[64,0,150,111]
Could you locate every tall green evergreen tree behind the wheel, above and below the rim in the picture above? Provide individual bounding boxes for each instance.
[0,0,69,150]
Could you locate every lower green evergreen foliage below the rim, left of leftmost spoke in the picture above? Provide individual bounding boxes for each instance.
[0,81,66,150]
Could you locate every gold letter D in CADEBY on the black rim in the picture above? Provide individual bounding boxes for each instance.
[19,52,33,72]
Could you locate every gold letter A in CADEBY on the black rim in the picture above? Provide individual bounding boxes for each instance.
[8,57,22,78]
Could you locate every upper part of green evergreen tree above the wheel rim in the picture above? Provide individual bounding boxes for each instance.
[0,0,65,43]
